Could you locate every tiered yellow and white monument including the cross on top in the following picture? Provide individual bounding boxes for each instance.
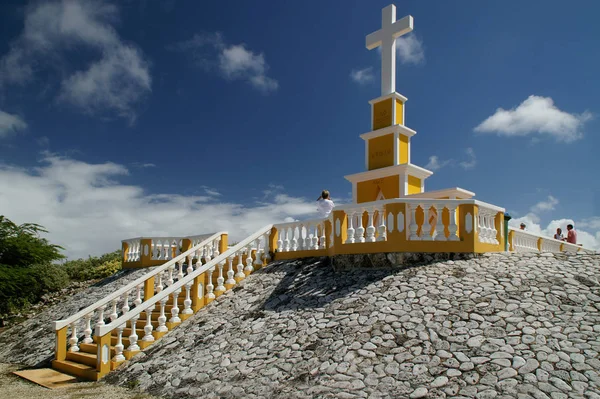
[345,4,475,203]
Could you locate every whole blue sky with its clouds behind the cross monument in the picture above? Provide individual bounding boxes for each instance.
[0,0,600,256]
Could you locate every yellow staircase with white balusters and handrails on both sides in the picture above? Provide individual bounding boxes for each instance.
[52,225,272,381]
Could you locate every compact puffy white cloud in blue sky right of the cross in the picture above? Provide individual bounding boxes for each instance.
[475,95,592,143]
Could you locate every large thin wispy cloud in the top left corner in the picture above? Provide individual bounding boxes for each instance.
[0,0,151,121]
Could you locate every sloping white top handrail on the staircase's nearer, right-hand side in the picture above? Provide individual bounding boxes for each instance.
[95,224,273,337]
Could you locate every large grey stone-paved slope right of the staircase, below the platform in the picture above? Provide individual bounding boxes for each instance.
[107,254,600,399]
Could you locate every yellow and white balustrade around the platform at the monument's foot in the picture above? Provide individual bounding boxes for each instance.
[271,199,506,259]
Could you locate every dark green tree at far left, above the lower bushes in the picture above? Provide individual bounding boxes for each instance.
[0,215,65,266]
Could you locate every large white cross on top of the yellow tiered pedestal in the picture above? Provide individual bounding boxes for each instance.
[367,4,413,96]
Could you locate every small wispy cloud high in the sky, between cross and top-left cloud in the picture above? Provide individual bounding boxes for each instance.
[169,32,279,93]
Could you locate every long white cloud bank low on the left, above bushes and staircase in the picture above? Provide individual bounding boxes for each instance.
[0,153,315,257]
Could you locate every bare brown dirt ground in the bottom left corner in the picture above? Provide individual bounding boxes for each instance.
[0,363,155,399]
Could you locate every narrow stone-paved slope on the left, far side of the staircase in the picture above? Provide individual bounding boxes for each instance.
[0,268,153,367]
